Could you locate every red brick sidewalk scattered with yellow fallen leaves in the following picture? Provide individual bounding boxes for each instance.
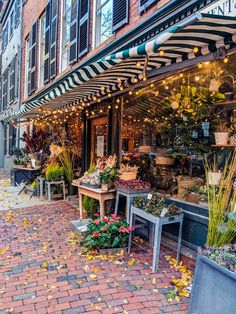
[0,202,194,314]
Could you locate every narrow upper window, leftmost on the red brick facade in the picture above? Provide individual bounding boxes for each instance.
[39,13,46,87]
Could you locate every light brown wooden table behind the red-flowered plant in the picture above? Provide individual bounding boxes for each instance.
[72,180,116,220]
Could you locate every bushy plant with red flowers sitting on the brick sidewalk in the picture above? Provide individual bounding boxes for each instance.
[82,213,134,254]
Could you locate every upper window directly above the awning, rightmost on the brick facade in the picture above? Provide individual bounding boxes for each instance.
[94,0,113,47]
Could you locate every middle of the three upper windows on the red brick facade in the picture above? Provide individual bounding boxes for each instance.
[61,0,71,71]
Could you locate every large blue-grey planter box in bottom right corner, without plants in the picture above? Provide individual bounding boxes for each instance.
[189,255,236,314]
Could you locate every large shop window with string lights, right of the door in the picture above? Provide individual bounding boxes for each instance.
[122,55,236,193]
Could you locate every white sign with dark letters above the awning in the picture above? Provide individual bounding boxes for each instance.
[202,0,236,17]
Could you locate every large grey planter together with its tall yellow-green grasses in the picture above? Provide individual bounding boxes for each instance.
[189,154,236,314]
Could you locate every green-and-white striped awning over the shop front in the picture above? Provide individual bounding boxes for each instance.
[3,13,236,121]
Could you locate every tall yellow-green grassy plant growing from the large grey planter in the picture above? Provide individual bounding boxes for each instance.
[205,151,236,248]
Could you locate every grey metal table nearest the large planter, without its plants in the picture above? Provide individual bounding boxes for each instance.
[128,206,184,272]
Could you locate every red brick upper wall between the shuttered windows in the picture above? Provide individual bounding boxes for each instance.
[21,0,170,103]
